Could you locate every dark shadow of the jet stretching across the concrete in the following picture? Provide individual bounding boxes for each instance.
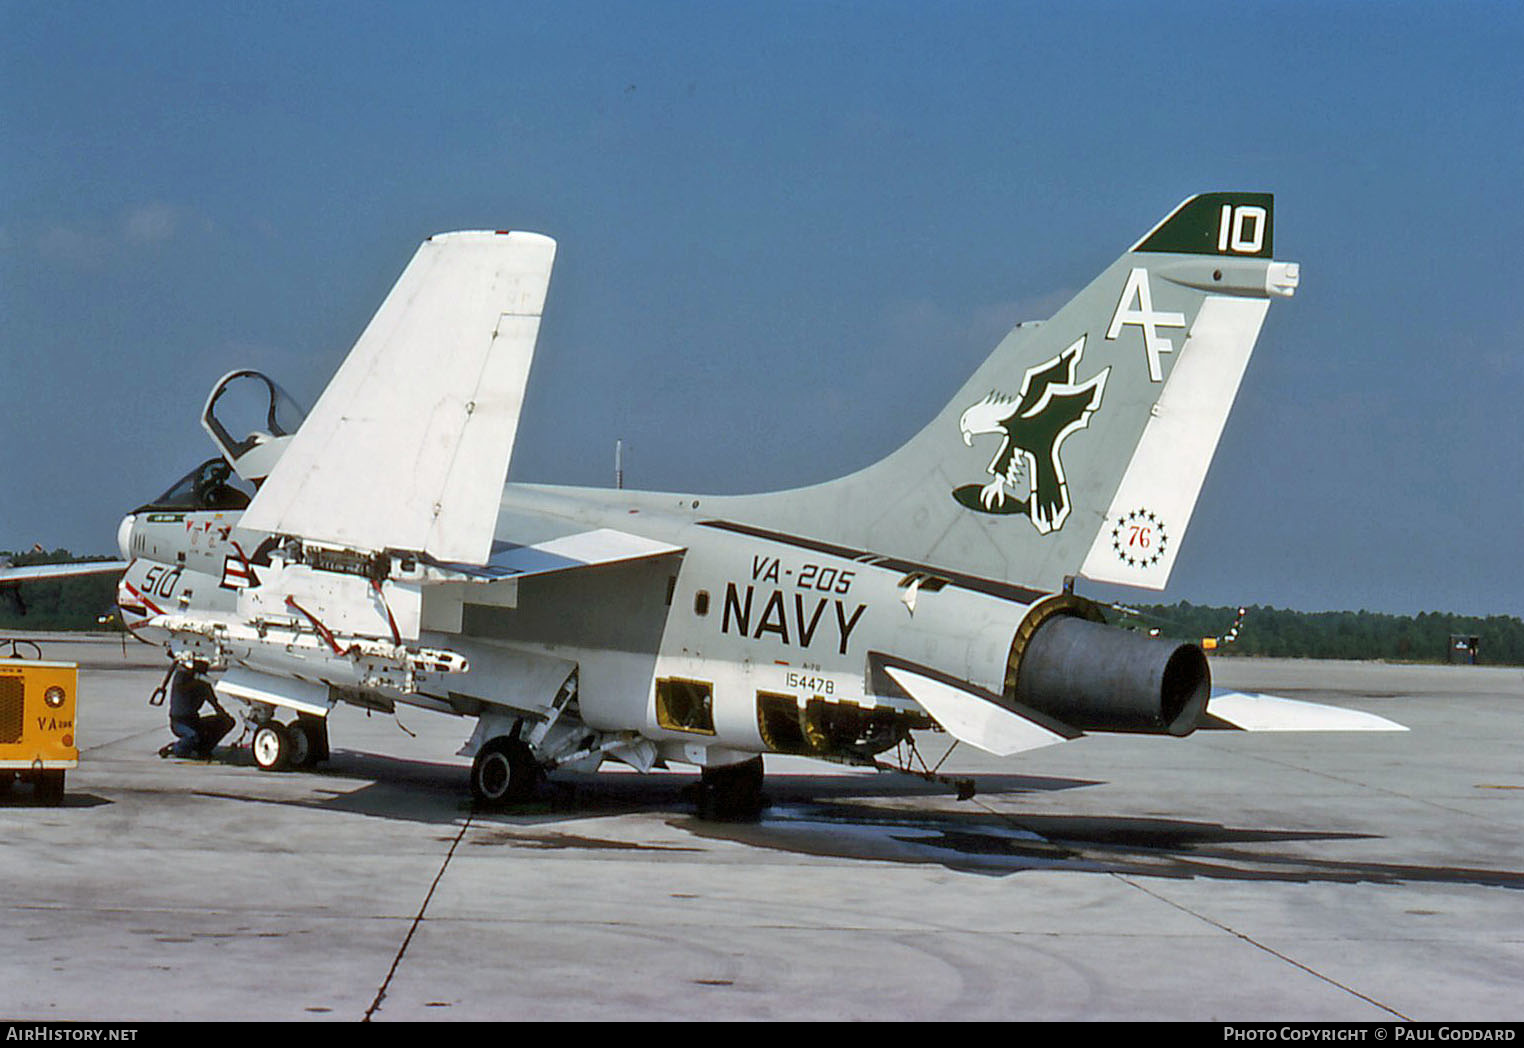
[175,749,1524,890]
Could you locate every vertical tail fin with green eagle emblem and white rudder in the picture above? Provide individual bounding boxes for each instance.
[707,193,1298,590]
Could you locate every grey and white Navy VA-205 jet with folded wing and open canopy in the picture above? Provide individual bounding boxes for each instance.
[101,193,1396,815]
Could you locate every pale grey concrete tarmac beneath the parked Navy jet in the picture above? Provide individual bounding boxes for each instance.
[0,637,1524,1022]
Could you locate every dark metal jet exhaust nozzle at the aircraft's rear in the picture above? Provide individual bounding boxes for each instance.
[1007,614,1212,736]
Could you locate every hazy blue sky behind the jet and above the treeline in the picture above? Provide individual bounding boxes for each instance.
[0,2,1524,614]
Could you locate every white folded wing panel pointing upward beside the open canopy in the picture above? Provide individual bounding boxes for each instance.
[242,232,556,565]
